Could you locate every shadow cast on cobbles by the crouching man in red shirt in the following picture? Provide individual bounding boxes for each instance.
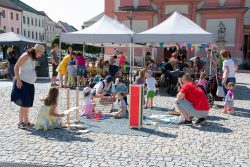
[192,122,233,133]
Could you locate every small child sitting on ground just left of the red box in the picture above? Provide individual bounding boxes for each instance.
[110,92,127,119]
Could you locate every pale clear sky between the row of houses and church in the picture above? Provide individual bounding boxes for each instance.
[21,0,104,29]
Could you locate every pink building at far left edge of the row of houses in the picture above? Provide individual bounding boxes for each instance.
[0,0,22,34]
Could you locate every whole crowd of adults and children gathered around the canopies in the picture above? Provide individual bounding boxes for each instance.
[11,44,236,130]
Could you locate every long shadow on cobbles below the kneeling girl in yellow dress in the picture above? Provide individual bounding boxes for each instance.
[31,129,94,142]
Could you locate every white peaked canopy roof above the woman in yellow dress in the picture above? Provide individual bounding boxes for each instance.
[60,15,134,45]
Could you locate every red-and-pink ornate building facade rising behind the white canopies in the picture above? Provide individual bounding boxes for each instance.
[105,0,250,64]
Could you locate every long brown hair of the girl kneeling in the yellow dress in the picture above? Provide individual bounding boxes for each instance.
[42,87,59,106]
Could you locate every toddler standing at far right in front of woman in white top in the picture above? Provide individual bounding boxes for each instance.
[222,82,235,114]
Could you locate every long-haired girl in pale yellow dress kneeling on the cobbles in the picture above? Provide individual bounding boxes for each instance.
[35,87,65,131]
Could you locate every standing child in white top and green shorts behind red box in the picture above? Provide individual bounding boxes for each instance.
[145,70,156,108]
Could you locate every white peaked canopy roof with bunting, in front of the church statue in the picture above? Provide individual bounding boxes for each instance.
[133,12,213,44]
